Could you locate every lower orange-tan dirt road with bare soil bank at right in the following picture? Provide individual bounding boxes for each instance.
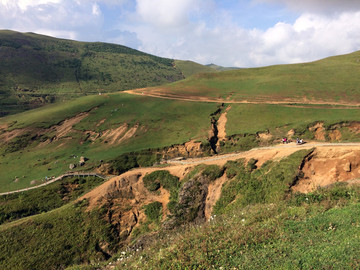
[80,143,360,206]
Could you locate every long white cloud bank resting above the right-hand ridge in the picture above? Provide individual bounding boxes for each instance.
[133,9,360,67]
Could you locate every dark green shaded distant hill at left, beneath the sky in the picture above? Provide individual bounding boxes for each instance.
[0,30,211,116]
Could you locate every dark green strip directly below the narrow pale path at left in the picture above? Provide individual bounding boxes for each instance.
[0,177,104,224]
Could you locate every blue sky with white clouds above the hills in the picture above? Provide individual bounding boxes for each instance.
[0,0,360,67]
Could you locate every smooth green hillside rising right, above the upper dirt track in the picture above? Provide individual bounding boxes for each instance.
[153,52,360,104]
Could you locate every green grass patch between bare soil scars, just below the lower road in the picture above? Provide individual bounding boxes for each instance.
[213,150,313,214]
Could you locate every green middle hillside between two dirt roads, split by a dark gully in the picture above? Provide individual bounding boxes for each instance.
[0,90,360,192]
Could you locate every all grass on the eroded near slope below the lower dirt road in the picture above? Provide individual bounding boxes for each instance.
[0,150,360,269]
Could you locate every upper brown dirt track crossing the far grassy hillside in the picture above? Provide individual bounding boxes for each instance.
[122,89,360,109]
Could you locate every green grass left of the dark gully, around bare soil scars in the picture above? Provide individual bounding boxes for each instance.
[0,93,217,191]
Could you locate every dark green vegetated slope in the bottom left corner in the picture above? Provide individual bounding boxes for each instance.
[0,202,118,269]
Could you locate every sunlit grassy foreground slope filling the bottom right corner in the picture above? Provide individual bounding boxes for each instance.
[100,185,360,269]
